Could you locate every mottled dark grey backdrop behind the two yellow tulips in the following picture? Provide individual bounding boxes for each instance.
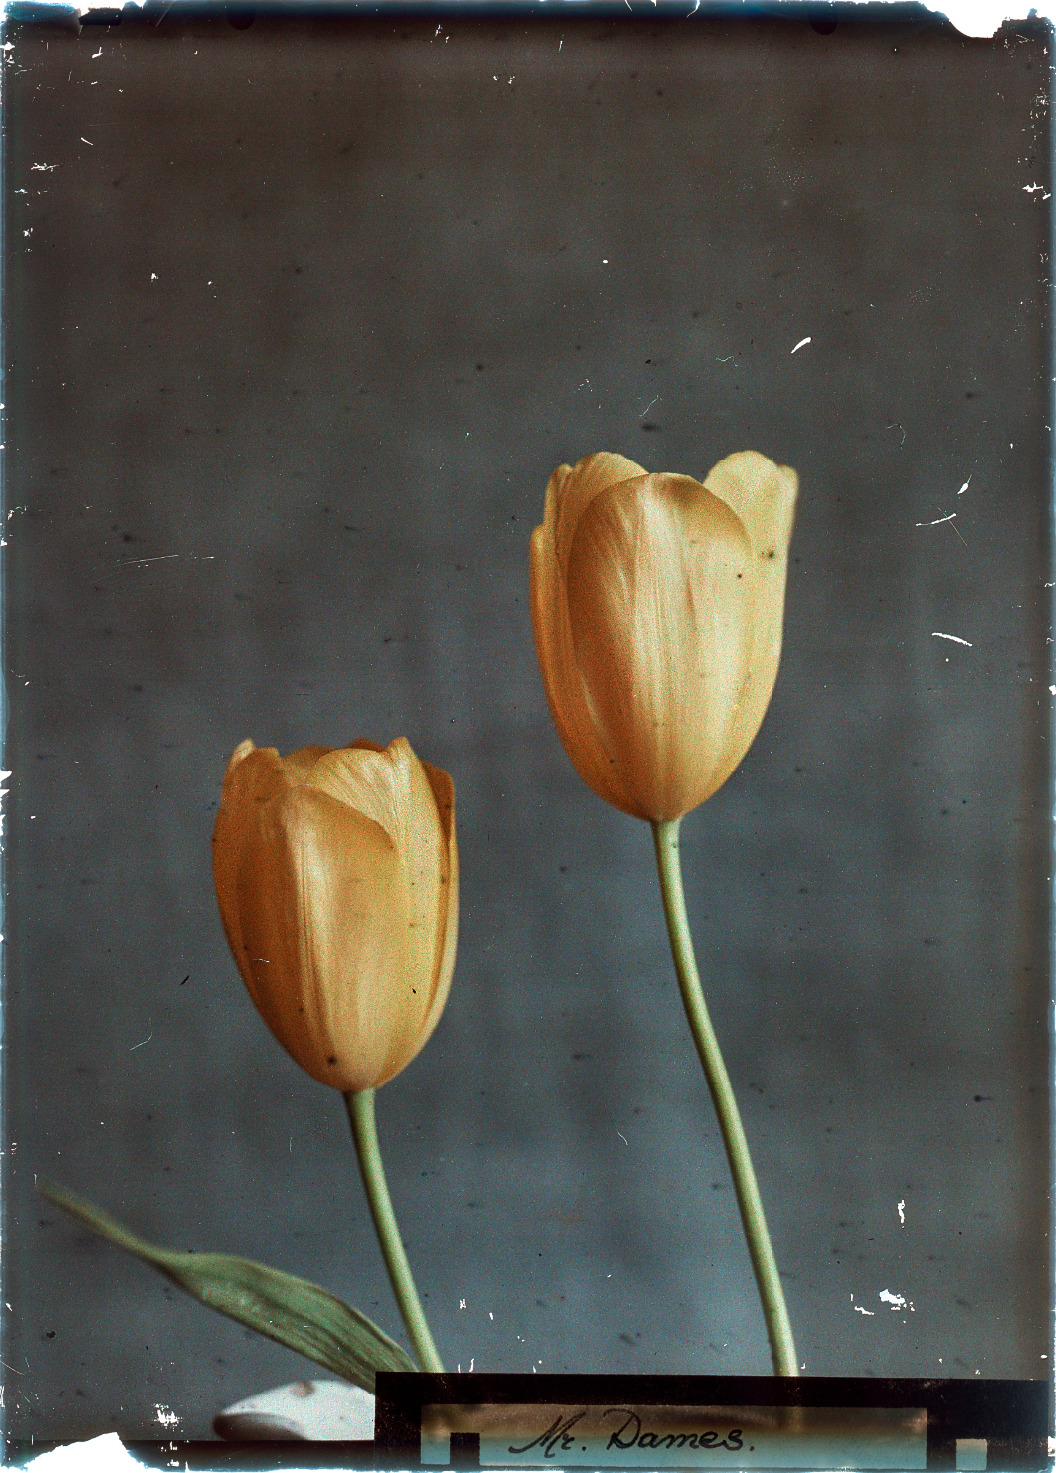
[3,6,1052,1438]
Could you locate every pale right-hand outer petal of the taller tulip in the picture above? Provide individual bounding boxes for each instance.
[705,451,798,782]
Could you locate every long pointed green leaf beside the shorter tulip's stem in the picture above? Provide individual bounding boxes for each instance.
[37,1183,418,1392]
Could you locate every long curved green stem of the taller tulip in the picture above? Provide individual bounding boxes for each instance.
[652,819,798,1376]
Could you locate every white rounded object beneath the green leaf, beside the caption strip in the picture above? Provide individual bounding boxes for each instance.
[213,1382,374,1437]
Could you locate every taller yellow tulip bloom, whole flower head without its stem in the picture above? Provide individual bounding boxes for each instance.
[532,451,798,822]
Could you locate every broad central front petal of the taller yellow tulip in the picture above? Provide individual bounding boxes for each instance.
[567,474,756,819]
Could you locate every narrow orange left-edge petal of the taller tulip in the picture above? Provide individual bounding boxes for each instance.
[530,526,648,819]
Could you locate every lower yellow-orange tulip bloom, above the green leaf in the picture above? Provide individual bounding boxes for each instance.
[214,738,458,1093]
